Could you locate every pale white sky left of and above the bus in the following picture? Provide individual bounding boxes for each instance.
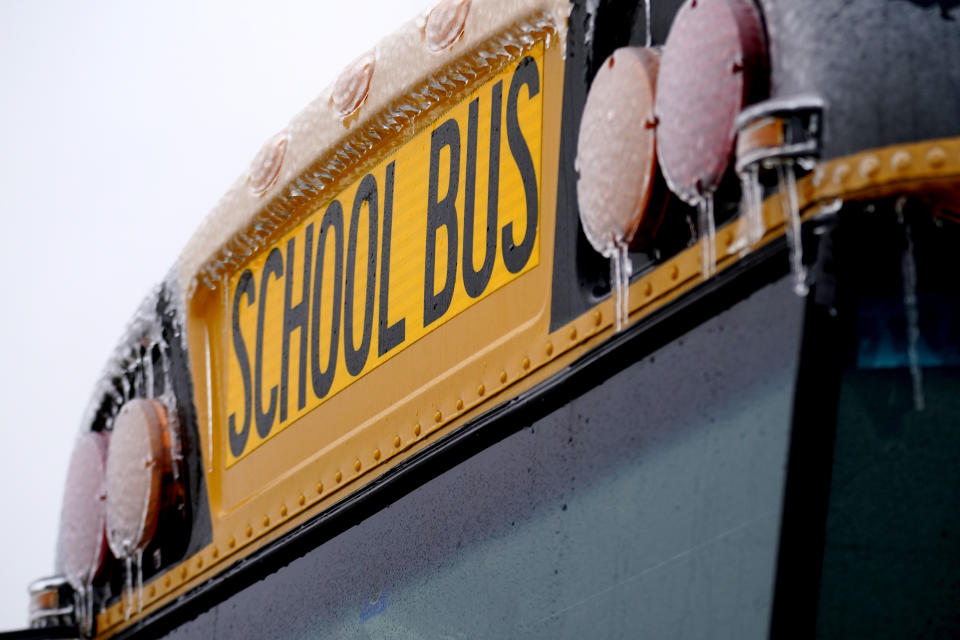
[0,0,429,629]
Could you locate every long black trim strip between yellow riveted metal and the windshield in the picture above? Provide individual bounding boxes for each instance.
[116,238,787,638]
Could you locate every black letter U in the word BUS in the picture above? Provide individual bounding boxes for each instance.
[463,80,503,298]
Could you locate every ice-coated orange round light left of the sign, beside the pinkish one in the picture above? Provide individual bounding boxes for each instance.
[106,398,168,558]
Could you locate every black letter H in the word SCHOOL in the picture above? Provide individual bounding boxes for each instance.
[280,224,313,423]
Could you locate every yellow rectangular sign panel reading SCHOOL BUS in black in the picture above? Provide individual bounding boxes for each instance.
[224,44,543,467]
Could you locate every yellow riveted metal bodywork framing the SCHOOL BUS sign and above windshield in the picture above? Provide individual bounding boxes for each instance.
[97,36,960,636]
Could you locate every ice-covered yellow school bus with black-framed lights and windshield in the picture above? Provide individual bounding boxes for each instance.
[16,0,960,638]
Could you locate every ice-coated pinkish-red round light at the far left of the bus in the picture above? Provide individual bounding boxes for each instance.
[56,431,108,591]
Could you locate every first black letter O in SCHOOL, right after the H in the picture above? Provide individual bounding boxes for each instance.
[310,200,343,399]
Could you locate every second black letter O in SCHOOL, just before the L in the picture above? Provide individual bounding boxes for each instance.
[343,173,378,376]
